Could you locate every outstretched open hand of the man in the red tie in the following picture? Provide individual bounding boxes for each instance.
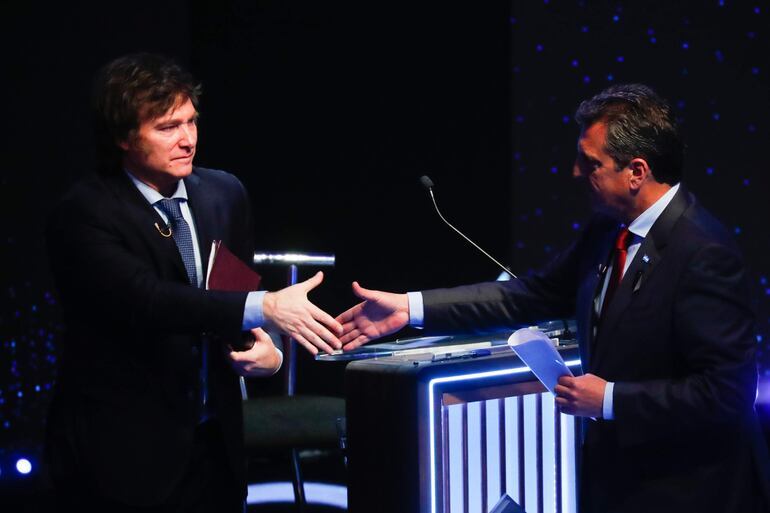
[337,281,409,351]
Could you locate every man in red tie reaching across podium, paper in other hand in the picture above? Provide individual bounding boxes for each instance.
[337,85,770,513]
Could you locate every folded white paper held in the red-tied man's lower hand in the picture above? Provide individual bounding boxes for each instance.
[508,328,573,393]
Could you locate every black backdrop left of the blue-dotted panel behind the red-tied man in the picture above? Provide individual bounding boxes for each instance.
[0,0,510,491]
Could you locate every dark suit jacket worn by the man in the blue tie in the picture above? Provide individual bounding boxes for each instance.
[47,168,253,505]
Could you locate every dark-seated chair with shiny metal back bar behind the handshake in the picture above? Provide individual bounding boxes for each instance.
[241,253,345,513]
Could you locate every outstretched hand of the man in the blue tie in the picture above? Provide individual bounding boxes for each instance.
[262,271,342,354]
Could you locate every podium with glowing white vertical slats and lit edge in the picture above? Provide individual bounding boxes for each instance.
[334,333,580,513]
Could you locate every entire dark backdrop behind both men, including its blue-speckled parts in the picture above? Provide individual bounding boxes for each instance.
[0,0,770,504]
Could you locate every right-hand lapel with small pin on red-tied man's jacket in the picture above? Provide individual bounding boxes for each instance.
[590,186,692,369]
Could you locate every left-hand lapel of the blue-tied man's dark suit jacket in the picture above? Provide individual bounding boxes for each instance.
[105,172,188,282]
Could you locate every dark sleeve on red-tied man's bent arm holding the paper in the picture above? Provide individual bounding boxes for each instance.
[614,244,757,442]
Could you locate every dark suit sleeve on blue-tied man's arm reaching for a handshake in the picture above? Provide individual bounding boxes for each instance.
[47,189,246,333]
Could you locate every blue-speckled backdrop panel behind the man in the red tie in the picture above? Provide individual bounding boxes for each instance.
[510,0,770,412]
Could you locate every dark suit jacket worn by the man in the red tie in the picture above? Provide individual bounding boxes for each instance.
[423,189,770,513]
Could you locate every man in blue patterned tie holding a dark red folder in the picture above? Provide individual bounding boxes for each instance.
[47,54,341,512]
